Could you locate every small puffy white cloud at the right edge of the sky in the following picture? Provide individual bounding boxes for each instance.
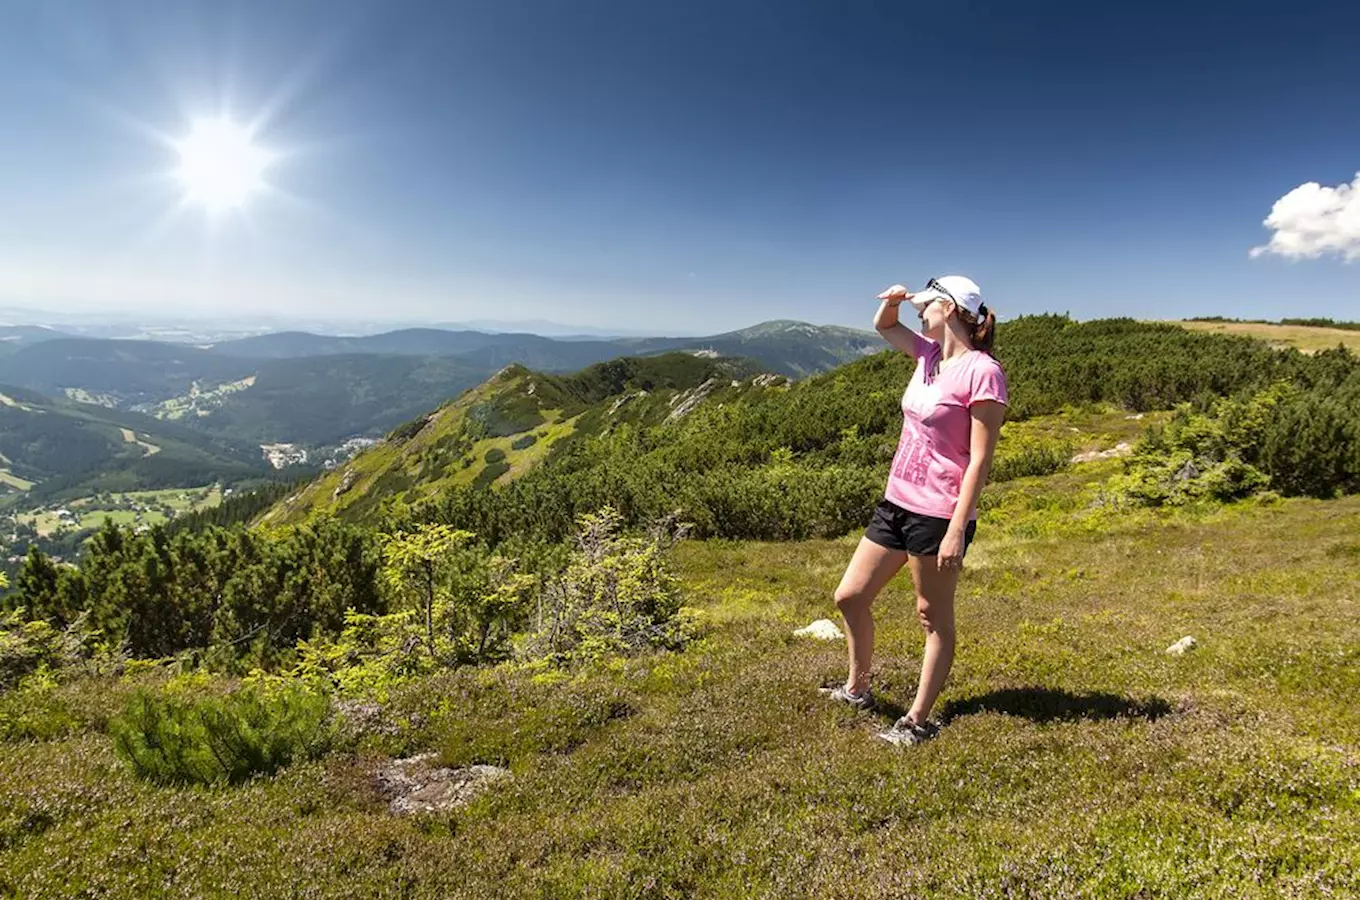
[1251,173,1360,261]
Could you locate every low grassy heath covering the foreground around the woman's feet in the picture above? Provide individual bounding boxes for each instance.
[0,494,1360,899]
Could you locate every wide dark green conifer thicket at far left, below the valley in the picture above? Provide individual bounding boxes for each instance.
[16,521,386,662]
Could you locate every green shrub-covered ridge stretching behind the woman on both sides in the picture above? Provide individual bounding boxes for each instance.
[259,317,1360,541]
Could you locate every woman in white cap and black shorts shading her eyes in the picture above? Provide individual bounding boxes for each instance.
[824,275,1006,744]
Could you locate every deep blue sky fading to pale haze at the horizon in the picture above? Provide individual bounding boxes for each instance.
[0,0,1360,333]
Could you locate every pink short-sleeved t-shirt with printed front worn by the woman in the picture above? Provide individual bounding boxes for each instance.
[884,332,1006,519]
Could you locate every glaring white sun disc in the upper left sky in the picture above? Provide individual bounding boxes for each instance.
[174,118,271,212]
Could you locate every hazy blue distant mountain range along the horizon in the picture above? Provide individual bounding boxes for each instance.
[0,321,883,446]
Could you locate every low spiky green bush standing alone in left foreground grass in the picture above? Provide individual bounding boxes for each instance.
[110,685,333,784]
